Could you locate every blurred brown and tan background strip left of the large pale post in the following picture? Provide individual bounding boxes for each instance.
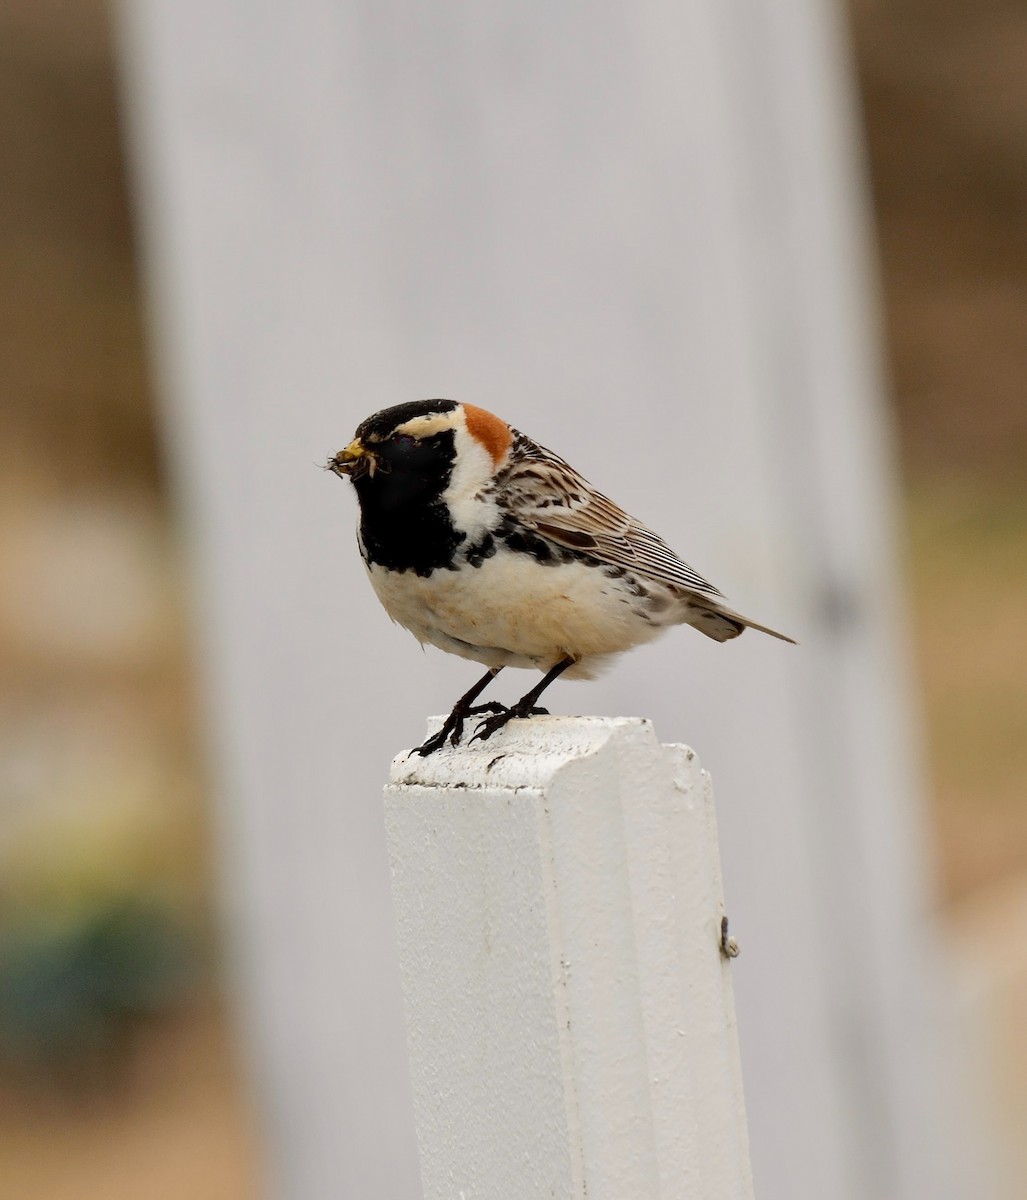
[0,0,259,1200]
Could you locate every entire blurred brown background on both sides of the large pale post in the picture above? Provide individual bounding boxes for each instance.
[0,0,1027,1200]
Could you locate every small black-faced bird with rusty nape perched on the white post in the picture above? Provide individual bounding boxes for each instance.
[325,400,794,756]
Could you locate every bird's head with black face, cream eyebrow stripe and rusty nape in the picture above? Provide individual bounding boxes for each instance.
[326,400,512,508]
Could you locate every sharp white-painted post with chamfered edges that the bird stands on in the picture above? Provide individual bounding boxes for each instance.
[385,716,752,1200]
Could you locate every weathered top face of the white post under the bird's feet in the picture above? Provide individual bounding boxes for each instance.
[389,716,691,788]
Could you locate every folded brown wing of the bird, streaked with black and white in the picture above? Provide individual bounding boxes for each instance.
[497,436,721,596]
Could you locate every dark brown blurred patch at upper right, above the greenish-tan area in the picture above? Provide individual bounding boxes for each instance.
[851,0,1027,477]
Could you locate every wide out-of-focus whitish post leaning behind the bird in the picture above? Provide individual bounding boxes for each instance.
[121,0,990,1200]
